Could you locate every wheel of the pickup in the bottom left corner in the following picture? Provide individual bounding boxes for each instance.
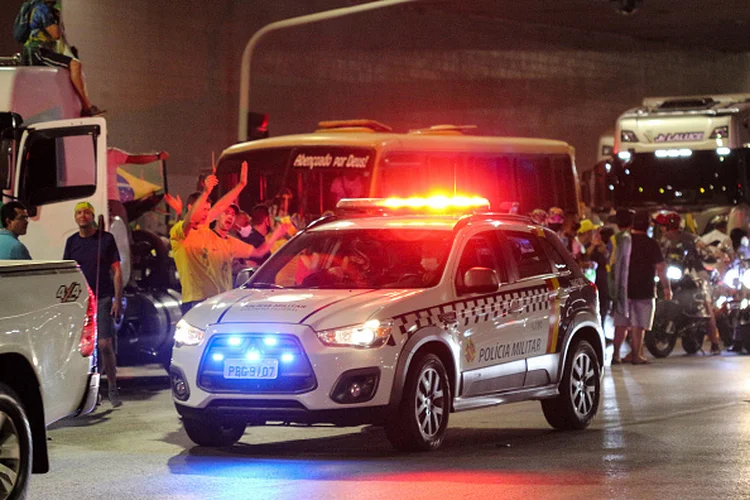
[0,384,33,500]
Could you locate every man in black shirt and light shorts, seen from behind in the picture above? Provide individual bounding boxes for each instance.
[628,212,672,365]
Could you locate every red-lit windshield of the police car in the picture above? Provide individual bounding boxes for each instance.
[246,228,453,289]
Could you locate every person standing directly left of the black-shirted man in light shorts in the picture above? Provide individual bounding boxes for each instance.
[602,209,635,365]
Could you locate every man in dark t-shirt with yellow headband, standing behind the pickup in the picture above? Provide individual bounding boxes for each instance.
[63,201,123,408]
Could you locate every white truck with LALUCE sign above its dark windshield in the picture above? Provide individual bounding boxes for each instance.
[605,94,750,231]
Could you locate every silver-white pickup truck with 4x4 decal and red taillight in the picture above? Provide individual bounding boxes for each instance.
[0,260,99,499]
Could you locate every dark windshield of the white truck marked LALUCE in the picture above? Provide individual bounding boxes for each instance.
[607,150,748,208]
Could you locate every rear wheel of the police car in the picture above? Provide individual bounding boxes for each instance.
[542,340,602,430]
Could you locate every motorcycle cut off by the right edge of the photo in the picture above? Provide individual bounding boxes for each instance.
[715,258,750,352]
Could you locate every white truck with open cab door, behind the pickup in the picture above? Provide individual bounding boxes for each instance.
[0,62,181,364]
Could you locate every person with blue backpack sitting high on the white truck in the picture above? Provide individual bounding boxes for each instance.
[23,0,104,116]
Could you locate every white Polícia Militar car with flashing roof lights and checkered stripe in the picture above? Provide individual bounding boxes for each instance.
[171,197,605,450]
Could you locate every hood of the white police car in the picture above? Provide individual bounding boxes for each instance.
[191,289,424,330]
